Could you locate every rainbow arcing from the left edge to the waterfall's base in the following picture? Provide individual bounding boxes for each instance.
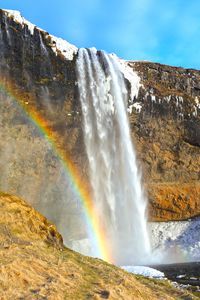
[0,78,113,263]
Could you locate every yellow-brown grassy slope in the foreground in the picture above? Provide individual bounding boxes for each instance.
[0,193,195,300]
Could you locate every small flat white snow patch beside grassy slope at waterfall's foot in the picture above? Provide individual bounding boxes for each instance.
[122,266,165,279]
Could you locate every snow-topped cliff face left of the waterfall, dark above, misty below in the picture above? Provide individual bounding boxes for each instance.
[0,10,86,244]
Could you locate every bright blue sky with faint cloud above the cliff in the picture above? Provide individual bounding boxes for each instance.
[0,0,200,69]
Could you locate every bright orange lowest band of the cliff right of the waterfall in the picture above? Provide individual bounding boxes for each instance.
[148,182,200,221]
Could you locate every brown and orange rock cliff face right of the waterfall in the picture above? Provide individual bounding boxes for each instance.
[129,62,200,220]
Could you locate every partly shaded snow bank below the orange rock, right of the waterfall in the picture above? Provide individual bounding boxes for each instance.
[149,218,200,263]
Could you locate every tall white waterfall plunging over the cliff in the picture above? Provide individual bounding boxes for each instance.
[76,48,150,265]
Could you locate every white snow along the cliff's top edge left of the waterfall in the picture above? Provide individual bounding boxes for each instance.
[3,9,78,60]
